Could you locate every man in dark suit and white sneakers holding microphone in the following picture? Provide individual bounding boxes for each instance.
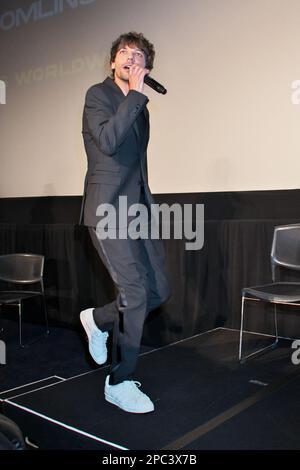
[80,32,169,413]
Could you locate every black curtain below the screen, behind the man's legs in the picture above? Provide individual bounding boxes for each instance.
[0,219,300,346]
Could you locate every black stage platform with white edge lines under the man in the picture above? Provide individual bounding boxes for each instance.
[0,328,300,450]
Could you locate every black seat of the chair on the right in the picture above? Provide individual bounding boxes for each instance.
[242,282,300,303]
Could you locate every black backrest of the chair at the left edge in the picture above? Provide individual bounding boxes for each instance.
[0,253,44,284]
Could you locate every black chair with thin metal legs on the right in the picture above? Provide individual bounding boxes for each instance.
[239,224,300,363]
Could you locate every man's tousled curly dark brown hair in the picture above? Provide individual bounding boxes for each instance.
[110,31,155,75]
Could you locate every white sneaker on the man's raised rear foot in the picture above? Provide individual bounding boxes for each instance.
[80,308,108,365]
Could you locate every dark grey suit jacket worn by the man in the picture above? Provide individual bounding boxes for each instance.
[80,77,153,227]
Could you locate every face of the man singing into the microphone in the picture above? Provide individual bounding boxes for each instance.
[111,45,146,82]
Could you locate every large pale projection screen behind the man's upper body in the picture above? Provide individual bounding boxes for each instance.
[0,0,300,197]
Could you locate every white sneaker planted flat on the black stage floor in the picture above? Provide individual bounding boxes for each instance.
[104,375,154,413]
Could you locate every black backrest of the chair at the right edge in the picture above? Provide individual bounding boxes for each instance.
[271,224,300,280]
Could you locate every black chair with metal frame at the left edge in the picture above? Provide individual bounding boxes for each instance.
[0,253,49,347]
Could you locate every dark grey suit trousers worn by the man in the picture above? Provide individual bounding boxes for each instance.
[89,228,170,385]
